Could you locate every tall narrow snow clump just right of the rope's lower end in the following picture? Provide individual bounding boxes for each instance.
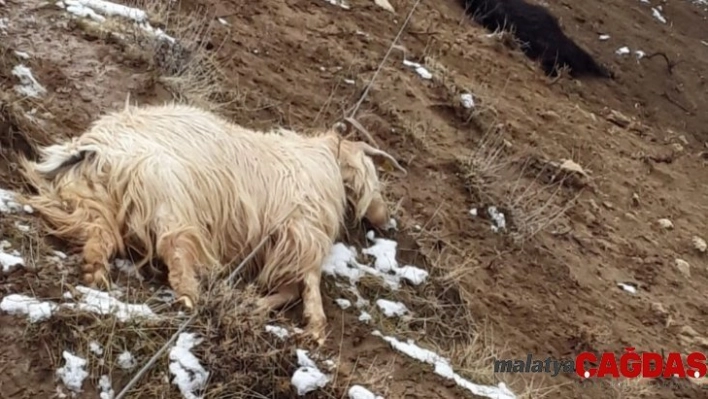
[170,333,209,399]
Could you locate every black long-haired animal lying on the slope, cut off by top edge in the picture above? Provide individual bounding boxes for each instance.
[461,0,614,78]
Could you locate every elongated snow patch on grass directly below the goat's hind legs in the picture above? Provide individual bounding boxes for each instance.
[65,285,157,321]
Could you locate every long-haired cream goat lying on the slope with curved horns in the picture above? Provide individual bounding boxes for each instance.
[21,104,405,344]
